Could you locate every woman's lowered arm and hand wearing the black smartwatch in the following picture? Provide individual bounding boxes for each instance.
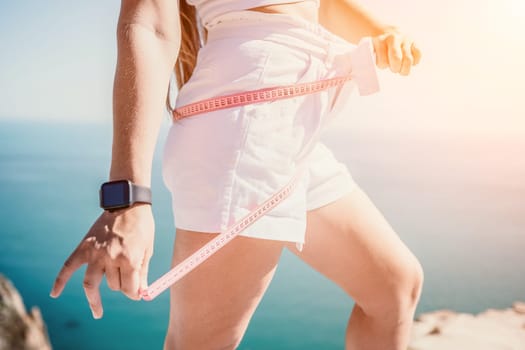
[51,0,180,318]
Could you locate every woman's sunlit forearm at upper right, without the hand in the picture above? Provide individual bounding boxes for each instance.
[319,0,393,43]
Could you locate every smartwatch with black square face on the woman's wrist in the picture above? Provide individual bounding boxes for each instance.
[99,180,151,211]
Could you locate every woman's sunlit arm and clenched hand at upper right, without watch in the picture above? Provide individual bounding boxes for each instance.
[319,0,421,75]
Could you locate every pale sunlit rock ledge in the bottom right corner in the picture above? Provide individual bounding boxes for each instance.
[408,302,525,350]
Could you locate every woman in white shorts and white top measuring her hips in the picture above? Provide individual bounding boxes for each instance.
[51,0,423,350]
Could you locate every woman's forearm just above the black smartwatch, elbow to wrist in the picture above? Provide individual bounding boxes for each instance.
[110,21,180,186]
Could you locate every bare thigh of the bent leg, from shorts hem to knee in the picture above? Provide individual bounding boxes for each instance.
[287,186,422,315]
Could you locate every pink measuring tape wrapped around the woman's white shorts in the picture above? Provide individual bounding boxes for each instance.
[140,38,379,301]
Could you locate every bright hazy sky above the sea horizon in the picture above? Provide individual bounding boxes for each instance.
[0,0,525,133]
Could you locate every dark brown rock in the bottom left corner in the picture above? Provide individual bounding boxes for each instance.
[0,274,51,350]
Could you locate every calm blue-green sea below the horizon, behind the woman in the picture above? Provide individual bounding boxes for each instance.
[0,121,525,350]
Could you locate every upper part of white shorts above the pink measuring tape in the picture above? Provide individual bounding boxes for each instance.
[176,11,355,106]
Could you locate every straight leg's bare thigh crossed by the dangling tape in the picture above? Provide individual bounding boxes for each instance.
[166,229,284,350]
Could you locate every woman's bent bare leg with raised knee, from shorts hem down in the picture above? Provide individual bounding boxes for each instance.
[287,187,423,350]
